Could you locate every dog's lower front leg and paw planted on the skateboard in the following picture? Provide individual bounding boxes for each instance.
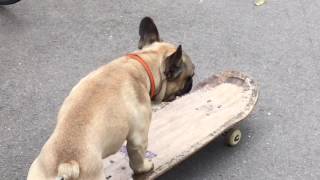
[127,128,153,174]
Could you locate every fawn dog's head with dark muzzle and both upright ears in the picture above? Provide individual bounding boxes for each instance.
[138,17,195,101]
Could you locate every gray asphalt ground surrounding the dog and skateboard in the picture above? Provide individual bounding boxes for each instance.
[0,0,320,180]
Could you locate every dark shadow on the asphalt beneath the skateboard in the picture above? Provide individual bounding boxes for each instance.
[158,120,255,180]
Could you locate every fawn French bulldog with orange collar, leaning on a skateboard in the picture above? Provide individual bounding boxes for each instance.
[27,17,195,180]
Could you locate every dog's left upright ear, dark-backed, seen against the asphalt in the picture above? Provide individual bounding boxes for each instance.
[138,17,160,49]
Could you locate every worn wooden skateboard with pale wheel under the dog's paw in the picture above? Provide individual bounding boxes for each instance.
[104,71,258,180]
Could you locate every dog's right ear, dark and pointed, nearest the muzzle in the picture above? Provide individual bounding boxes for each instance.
[164,45,182,81]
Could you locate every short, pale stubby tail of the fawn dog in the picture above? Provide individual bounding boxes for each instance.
[56,161,80,180]
